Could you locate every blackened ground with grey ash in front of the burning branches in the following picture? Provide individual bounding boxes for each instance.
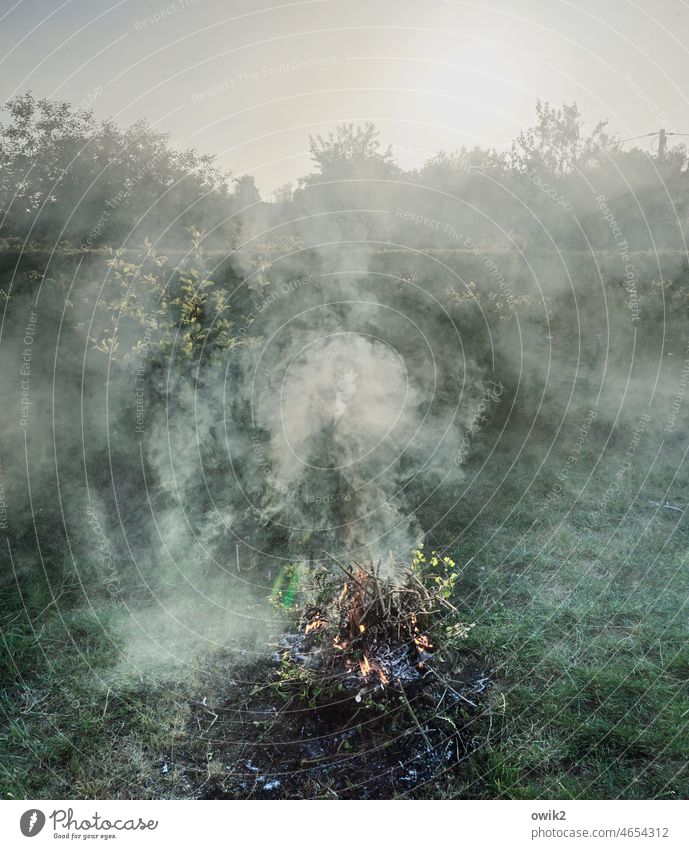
[168,644,491,799]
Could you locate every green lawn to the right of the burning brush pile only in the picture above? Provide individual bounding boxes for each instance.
[440,460,689,799]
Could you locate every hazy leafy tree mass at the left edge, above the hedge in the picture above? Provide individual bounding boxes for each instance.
[0,92,228,248]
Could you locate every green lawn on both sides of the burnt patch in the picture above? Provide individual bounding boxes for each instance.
[0,434,689,799]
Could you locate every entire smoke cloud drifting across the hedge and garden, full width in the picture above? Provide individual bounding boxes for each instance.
[0,102,687,684]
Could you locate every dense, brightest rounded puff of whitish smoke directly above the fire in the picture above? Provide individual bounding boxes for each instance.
[255,330,422,559]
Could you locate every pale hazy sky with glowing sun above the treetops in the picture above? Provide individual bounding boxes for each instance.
[0,0,689,195]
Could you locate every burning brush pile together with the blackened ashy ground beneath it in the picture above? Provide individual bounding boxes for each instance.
[181,547,486,799]
